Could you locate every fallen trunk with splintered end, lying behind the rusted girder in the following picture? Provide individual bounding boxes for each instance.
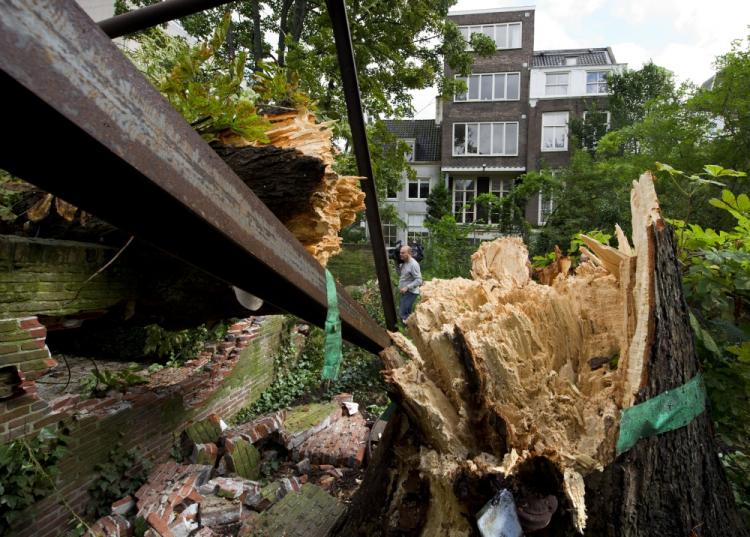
[7,109,365,266]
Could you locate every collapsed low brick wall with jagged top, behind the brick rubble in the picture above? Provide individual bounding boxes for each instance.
[0,316,283,537]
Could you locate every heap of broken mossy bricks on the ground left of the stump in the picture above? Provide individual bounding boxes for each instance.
[88,394,370,537]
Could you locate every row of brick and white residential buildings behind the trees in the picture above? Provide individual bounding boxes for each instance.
[388,7,623,245]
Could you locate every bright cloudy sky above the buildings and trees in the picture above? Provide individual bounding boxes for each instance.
[414,0,750,119]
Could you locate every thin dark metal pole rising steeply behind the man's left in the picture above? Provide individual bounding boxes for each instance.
[326,0,396,330]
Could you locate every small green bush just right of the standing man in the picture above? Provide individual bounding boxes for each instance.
[421,214,477,279]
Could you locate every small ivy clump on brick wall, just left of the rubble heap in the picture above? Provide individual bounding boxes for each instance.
[88,443,153,518]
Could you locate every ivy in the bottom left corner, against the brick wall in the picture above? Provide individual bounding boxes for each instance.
[0,427,69,535]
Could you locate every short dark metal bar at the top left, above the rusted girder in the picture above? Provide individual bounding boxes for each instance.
[97,0,233,39]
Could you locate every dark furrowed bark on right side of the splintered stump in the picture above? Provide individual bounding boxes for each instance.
[586,226,748,537]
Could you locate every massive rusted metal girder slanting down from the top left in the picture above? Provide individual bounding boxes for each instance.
[0,0,389,352]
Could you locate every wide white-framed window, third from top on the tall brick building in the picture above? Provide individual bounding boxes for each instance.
[453,121,518,156]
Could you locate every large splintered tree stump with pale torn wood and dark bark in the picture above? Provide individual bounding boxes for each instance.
[335,174,747,537]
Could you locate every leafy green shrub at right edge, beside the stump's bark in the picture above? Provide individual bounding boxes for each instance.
[671,186,750,520]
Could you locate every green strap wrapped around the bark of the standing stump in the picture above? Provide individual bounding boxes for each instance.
[617,373,706,455]
